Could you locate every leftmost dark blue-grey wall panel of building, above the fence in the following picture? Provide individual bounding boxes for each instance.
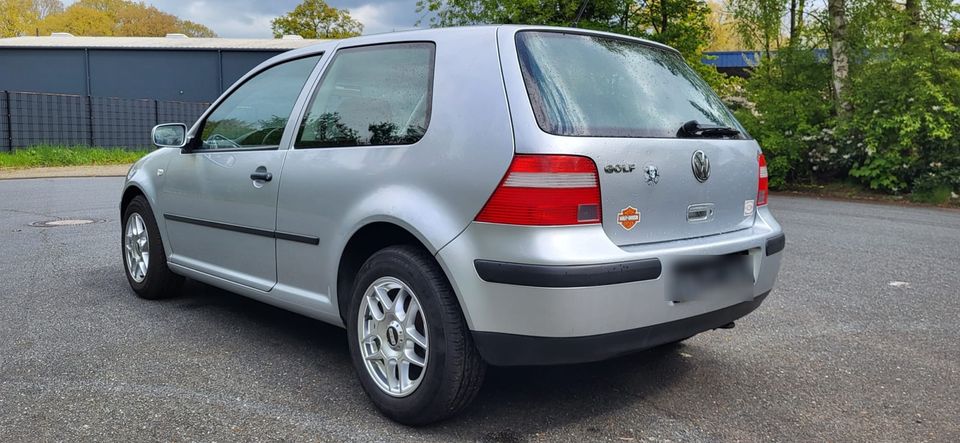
[0,48,86,95]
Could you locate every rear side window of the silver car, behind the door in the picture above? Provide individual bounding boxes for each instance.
[294,43,435,148]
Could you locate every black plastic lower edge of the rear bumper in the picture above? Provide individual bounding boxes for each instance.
[473,291,770,366]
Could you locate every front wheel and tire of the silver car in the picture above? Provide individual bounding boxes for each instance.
[120,195,184,300]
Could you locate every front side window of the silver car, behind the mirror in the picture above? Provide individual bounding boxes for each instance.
[200,55,320,149]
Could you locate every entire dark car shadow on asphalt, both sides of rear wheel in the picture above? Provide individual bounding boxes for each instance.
[148,281,691,442]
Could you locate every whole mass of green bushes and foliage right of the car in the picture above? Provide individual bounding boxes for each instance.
[735,0,960,201]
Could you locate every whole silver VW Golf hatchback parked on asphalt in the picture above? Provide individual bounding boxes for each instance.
[120,26,784,424]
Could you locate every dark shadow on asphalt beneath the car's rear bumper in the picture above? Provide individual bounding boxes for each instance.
[431,345,691,442]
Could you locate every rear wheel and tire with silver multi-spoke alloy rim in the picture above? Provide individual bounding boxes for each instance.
[347,246,486,426]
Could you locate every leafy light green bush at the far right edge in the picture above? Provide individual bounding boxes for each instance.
[843,41,960,193]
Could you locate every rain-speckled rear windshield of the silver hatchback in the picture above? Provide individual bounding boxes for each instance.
[517,31,746,138]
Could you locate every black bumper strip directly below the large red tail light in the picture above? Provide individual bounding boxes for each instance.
[473,258,662,288]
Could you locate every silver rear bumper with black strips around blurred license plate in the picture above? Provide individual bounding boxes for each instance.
[437,207,784,358]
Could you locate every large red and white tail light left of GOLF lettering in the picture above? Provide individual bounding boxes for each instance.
[476,155,601,226]
